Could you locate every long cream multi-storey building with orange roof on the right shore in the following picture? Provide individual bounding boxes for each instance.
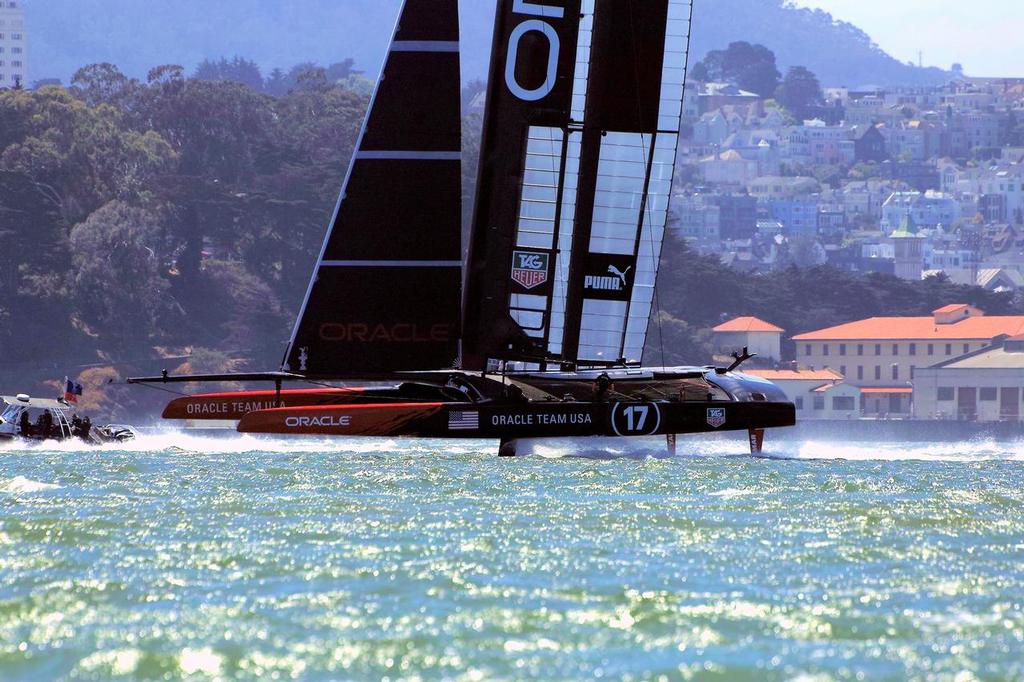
[793,304,1024,415]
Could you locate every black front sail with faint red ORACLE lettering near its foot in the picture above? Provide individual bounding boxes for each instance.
[285,0,462,377]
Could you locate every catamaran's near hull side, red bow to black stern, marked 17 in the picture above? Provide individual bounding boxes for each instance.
[239,402,796,440]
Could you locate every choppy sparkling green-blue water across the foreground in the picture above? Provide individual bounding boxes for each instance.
[0,436,1024,680]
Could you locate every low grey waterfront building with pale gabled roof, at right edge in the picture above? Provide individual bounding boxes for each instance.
[913,336,1024,422]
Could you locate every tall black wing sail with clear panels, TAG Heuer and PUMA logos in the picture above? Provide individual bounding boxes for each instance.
[464,0,692,369]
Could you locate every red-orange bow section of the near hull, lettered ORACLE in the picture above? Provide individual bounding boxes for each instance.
[239,402,444,436]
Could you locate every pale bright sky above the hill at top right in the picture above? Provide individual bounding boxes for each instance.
[794,0,1024,76]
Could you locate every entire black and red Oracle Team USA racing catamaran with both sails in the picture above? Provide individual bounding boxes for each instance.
[131,0,796,456]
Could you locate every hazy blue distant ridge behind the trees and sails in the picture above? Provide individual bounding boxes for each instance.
[26,0,948,87]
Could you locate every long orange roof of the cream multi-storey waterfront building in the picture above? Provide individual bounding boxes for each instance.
[793,315,1024,341]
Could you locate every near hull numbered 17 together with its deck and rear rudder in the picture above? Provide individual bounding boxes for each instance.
[239,368,796,452]
